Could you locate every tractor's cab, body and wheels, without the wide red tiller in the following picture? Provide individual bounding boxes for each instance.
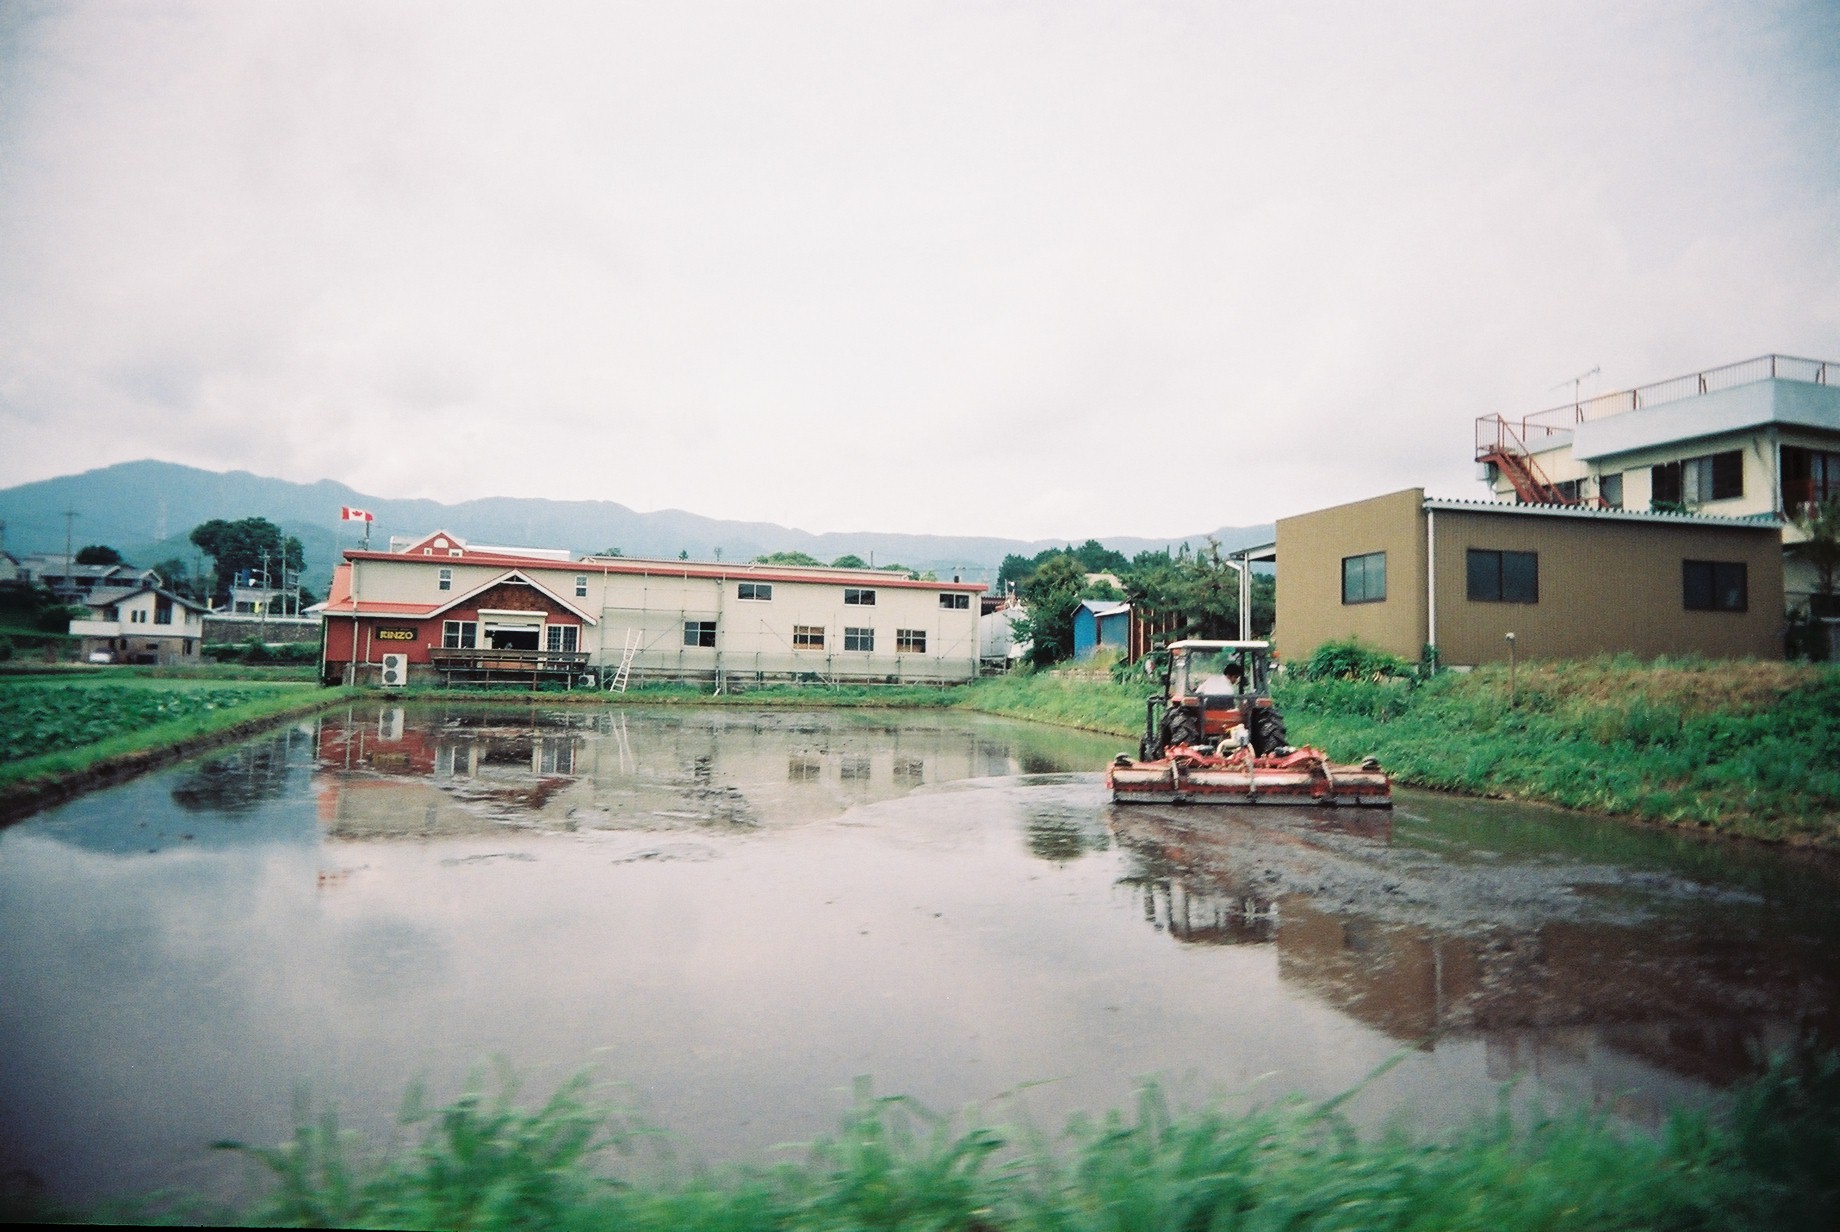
[1137,640,1290,761]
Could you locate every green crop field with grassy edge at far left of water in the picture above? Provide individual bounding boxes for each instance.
[0,669,356,813]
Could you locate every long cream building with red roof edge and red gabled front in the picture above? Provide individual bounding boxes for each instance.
[324,531,984,688]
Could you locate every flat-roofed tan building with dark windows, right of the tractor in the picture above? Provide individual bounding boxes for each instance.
[1275,487,1783,666]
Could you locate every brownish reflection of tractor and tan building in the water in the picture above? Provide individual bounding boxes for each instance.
[1113,809,1834,1120]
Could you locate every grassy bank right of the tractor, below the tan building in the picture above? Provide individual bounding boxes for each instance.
[1277,656,1840,846]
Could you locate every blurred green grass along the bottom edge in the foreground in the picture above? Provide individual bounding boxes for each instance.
[32,1055,1840,1232]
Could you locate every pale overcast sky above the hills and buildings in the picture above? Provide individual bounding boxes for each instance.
[0,0,1840,539]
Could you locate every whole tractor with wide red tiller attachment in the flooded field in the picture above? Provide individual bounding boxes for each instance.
[1106,640,1393,807]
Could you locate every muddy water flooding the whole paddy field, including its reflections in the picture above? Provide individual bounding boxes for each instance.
[0,706,1840,1195]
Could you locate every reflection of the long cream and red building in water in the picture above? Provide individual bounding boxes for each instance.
[318,706,1074,837]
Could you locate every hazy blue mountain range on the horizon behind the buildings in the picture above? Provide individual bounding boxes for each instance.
[0,460,1271,594]
